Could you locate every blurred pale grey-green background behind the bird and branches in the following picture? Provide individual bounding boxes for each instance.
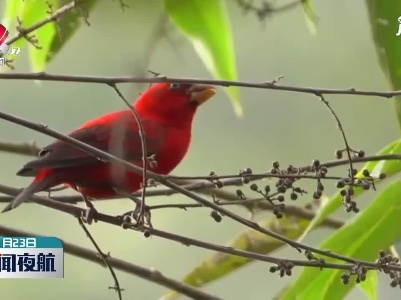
[0,0,399,300]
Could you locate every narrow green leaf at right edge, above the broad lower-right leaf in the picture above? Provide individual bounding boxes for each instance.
[299,139,401,241]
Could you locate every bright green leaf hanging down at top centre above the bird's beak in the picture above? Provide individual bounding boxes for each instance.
[164,0,242,115]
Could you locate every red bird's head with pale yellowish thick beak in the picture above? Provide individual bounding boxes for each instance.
[135,82,216,126]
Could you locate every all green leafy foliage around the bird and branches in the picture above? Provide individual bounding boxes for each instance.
[2,0,401,299]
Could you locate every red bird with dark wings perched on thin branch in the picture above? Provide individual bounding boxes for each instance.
[2,83,216,212]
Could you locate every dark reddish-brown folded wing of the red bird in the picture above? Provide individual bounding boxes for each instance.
[17,111,167,176]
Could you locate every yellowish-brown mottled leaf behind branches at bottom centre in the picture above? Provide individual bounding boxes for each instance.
[162,215,309,300]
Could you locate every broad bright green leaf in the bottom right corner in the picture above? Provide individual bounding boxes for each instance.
[280,180,401,300]
